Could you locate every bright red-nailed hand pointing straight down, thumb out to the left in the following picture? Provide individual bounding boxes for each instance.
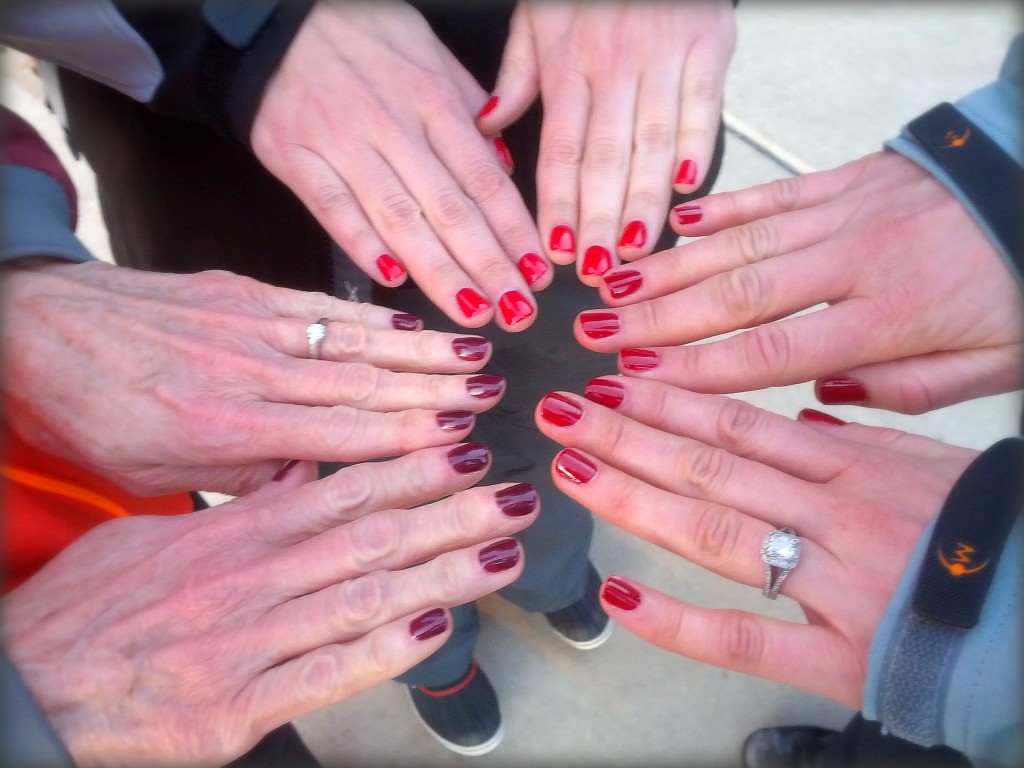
[477,0,735,285]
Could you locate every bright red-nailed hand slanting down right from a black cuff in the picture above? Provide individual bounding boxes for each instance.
[251,0,554,331]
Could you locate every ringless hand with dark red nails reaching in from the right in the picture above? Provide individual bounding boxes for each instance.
[577,152,1024,414]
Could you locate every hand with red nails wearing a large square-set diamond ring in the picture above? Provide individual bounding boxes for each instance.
[537,377,977,709]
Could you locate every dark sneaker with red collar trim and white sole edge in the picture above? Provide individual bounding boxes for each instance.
[406,660,505,757]
